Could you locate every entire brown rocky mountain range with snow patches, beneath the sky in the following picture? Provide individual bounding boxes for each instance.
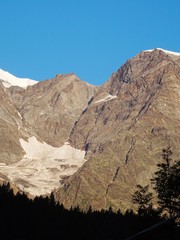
[0,49,180,210]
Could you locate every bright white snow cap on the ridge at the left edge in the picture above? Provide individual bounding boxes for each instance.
[0,69,38,88]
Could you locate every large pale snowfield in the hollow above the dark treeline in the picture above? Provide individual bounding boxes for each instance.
[0,137,86,196]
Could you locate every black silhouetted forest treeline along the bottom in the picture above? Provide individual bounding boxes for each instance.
[0,184,179,240]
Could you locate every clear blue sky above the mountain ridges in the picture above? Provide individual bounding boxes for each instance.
[0,0,180,85]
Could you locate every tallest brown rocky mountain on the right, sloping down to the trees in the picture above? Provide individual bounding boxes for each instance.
[56,49,180,210]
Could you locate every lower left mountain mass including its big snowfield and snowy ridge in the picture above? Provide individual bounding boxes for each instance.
[0,72,97,195]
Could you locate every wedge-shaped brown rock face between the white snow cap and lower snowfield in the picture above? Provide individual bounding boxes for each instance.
[8,74,96,147]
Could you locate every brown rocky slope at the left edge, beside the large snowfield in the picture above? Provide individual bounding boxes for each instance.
[0,84,31,164]
